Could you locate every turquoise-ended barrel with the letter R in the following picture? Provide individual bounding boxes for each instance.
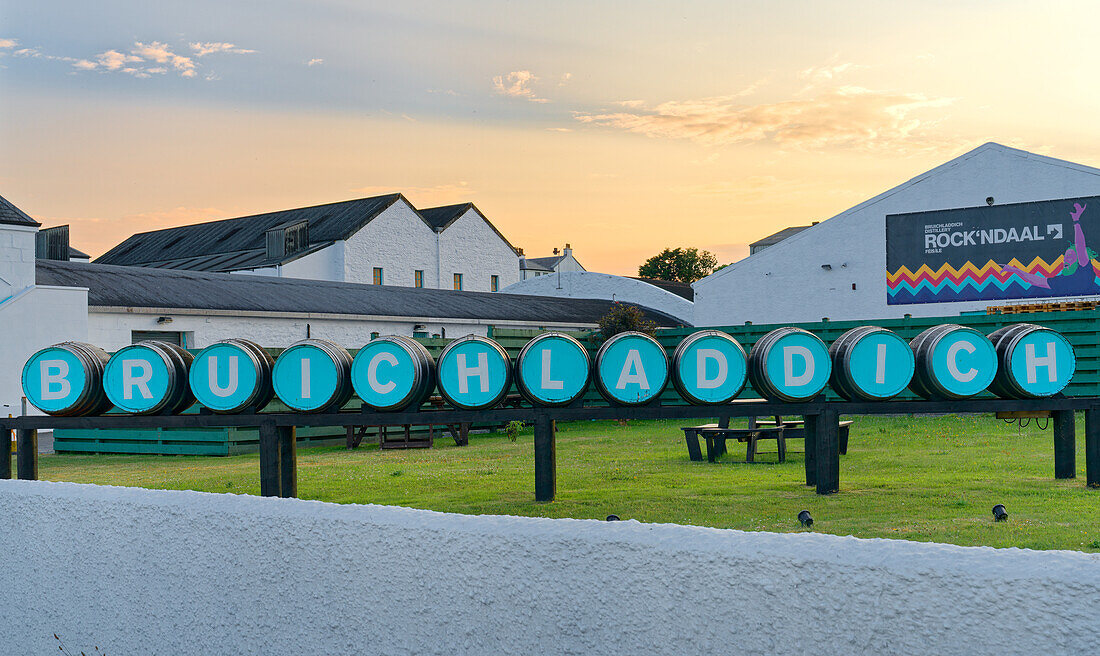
[103,339,195,415]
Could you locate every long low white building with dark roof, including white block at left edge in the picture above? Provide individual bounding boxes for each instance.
[0,192,682,415]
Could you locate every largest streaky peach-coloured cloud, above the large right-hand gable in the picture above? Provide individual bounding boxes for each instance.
[574,86,953,151]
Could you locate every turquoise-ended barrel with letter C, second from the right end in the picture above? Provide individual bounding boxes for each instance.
[909,324,997,401]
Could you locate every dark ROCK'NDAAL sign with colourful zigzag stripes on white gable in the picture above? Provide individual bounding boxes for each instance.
[887,196,1100,305]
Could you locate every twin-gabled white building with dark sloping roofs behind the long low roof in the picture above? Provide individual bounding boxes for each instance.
[96,194,520,292]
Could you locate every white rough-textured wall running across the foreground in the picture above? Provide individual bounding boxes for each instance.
[0,481,1100,655]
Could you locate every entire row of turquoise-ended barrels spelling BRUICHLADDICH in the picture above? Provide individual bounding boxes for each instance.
[23,324,1076,416]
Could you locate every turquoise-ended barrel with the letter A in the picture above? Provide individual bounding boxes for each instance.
[596,331,669,405]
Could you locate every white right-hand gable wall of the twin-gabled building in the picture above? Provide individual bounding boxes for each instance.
[439,208,519,292]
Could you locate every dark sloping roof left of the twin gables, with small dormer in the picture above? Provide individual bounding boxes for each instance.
[96,194,411,271]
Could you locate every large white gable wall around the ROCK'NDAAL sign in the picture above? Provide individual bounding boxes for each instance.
[693,143,1100,326]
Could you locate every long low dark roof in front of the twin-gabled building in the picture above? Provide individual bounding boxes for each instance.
[36,260,682,326]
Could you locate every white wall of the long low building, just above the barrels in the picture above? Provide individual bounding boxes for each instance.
[89,307,595,354]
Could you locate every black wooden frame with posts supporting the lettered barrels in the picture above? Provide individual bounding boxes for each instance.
[0,396,1100,502]
